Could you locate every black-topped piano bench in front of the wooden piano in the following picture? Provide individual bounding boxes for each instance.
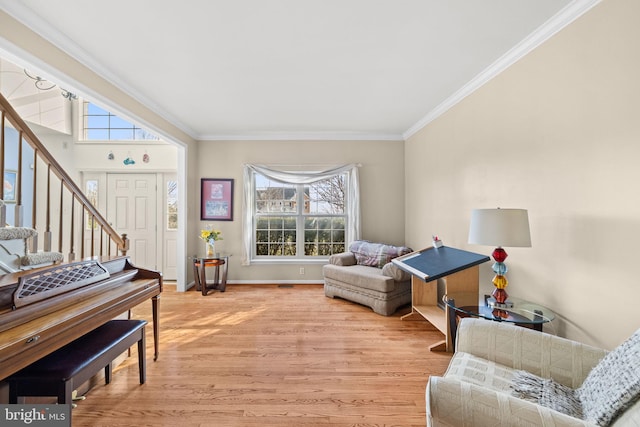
[7,320,147,404]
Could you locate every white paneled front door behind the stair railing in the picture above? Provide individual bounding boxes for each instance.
[106,173,159,270]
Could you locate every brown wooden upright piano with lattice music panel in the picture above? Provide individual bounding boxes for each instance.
[0,256,162,380]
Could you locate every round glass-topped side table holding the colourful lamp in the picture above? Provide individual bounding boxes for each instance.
[442,292,556,352]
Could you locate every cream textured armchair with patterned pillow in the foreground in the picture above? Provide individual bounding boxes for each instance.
[426,318,640,427]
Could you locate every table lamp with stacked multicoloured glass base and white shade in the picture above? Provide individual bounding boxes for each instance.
[469,208,531,307]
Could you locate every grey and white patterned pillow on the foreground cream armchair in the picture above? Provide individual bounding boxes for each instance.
[576,329,640,426]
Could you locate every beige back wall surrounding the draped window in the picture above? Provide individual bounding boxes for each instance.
[194,141,404,283]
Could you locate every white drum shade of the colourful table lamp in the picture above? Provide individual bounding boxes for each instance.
[469,208,531,247]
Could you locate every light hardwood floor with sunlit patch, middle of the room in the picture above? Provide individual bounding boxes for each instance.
[72,285,450,427]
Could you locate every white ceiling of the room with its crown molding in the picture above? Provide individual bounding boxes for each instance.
[0,0,597,140]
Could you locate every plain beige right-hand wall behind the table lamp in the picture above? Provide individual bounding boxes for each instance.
[405,0,640,348]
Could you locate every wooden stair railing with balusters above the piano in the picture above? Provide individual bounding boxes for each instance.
[0,94,129,261]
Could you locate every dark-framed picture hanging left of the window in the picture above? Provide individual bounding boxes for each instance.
[200,178,233,221]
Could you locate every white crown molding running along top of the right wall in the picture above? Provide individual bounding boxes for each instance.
[402,0,602,141]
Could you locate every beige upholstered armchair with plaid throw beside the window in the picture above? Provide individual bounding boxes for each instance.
[322,241,412,316]
